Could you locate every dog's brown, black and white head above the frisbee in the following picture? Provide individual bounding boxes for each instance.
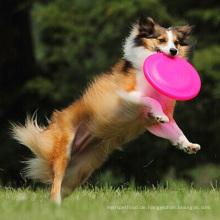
[124,15,195,67]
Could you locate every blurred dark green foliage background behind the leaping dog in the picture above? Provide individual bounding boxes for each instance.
[0,0,220,187]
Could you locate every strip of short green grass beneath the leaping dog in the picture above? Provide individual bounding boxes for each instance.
[0,186,220,220]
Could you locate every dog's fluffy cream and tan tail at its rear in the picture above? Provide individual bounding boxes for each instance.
[11,116,53,182]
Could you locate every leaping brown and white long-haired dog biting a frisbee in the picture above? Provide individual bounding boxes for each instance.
[11,15,200,204]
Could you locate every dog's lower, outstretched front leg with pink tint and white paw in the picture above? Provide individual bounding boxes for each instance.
[147,119,200,154]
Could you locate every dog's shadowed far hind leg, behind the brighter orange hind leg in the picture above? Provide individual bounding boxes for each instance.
[58,122,103,199]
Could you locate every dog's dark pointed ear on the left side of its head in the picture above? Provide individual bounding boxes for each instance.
[139,14,155,35]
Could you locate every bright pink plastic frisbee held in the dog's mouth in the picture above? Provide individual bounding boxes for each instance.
[143,53,201,101]
